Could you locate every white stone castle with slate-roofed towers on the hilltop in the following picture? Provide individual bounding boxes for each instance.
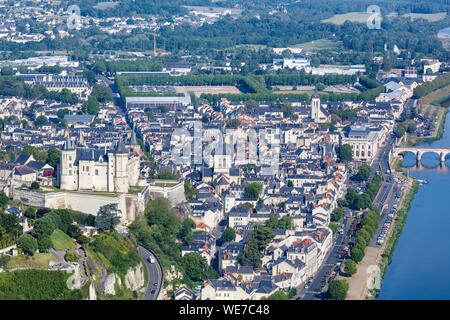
[58,132,140,193]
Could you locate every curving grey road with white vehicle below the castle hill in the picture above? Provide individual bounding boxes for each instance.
[138,246,163,300]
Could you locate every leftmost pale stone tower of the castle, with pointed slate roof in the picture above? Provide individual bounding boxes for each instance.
[58,137,78,190]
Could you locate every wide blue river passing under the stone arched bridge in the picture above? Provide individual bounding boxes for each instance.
[378,112,450,300]
